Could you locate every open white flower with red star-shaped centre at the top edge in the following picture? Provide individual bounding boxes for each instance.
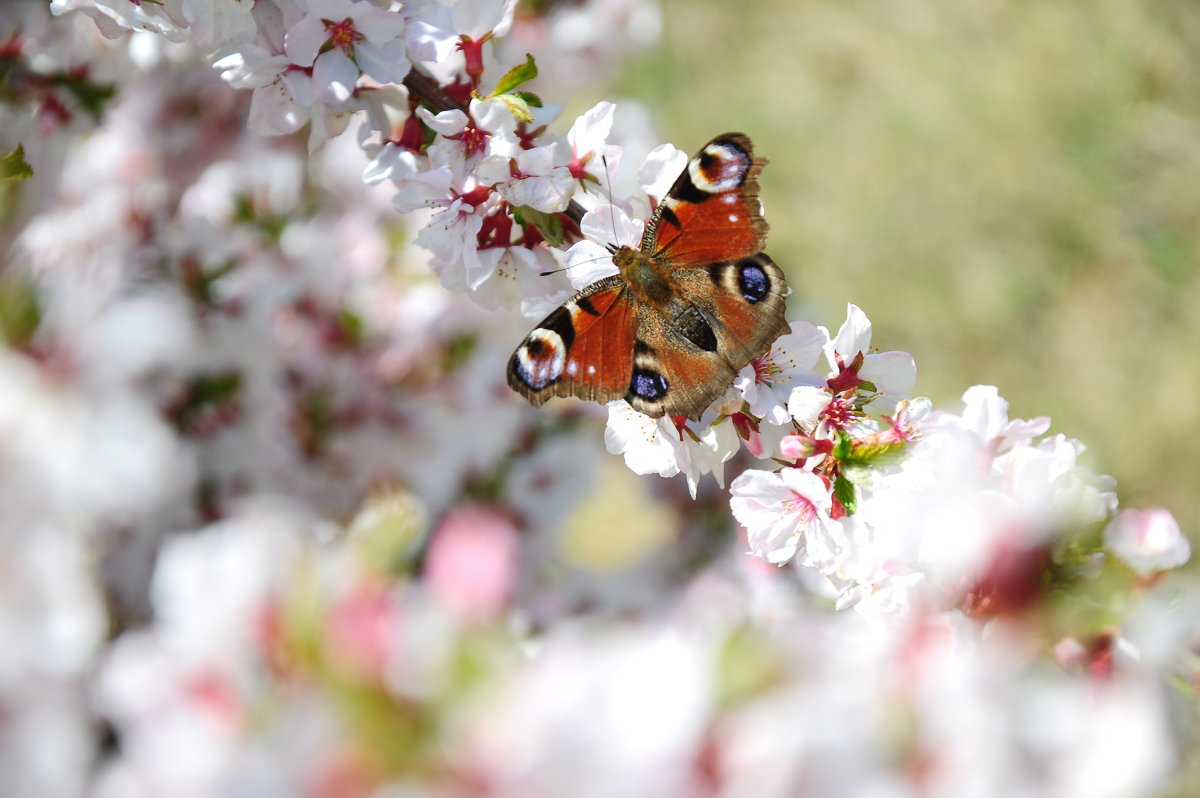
[284,0,410,103]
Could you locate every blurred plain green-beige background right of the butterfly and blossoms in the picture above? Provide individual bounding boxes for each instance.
[604,0,1200,535]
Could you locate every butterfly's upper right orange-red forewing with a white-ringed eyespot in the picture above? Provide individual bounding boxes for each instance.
[642,133,769,268]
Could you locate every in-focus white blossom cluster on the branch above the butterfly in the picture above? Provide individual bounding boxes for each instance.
[50,0,638,307]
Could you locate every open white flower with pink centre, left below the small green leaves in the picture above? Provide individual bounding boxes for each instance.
[730,468,840,571]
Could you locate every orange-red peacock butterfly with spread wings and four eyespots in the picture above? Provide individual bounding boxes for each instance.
[508,133,788,419]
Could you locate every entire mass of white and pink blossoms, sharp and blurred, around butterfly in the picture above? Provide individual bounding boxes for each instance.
[0,0,1200,798]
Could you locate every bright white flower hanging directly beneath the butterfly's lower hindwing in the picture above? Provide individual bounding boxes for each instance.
[604,400,738,498]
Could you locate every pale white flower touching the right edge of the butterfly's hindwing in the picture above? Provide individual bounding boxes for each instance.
[733,322,829,425]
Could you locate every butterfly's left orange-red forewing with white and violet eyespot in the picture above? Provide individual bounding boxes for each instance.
[508,277,636,406]
